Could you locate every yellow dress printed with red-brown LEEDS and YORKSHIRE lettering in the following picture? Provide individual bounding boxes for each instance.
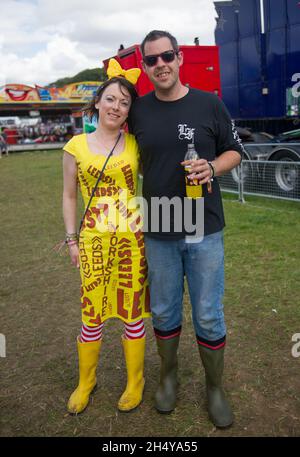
[64,133,150,326]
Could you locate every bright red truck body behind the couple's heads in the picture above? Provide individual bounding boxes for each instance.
[103,44,221,96]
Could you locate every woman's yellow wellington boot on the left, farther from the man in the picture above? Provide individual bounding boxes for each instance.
[68,340,101,414]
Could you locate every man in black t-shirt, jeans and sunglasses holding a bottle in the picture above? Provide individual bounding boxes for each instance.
[130,31,243,427]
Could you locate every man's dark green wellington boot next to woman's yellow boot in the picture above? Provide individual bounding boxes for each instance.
[155,336,179,414]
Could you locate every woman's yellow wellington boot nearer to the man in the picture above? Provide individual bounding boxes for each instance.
[118,337,146,412]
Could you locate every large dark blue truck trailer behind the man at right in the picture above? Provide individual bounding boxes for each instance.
[214,0,300,135]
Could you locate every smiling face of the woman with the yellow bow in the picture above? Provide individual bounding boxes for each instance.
[95,83,131,129]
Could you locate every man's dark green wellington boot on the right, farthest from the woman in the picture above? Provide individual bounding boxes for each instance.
[198,345,233,428]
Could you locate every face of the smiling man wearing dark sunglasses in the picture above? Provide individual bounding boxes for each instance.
[143,37,183,92]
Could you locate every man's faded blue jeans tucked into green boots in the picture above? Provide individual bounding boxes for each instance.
[145,231,226,342]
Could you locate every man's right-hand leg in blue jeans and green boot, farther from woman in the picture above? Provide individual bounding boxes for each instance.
[185,232,233,427]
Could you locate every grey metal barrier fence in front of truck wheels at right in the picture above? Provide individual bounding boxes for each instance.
[218,144,300,202]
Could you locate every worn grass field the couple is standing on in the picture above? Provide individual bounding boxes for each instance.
[0,151,300,437]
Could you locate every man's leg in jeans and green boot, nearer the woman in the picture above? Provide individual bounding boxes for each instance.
[145,236,184,413]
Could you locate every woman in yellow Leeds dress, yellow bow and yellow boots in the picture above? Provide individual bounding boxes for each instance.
[63,59,150,414]
